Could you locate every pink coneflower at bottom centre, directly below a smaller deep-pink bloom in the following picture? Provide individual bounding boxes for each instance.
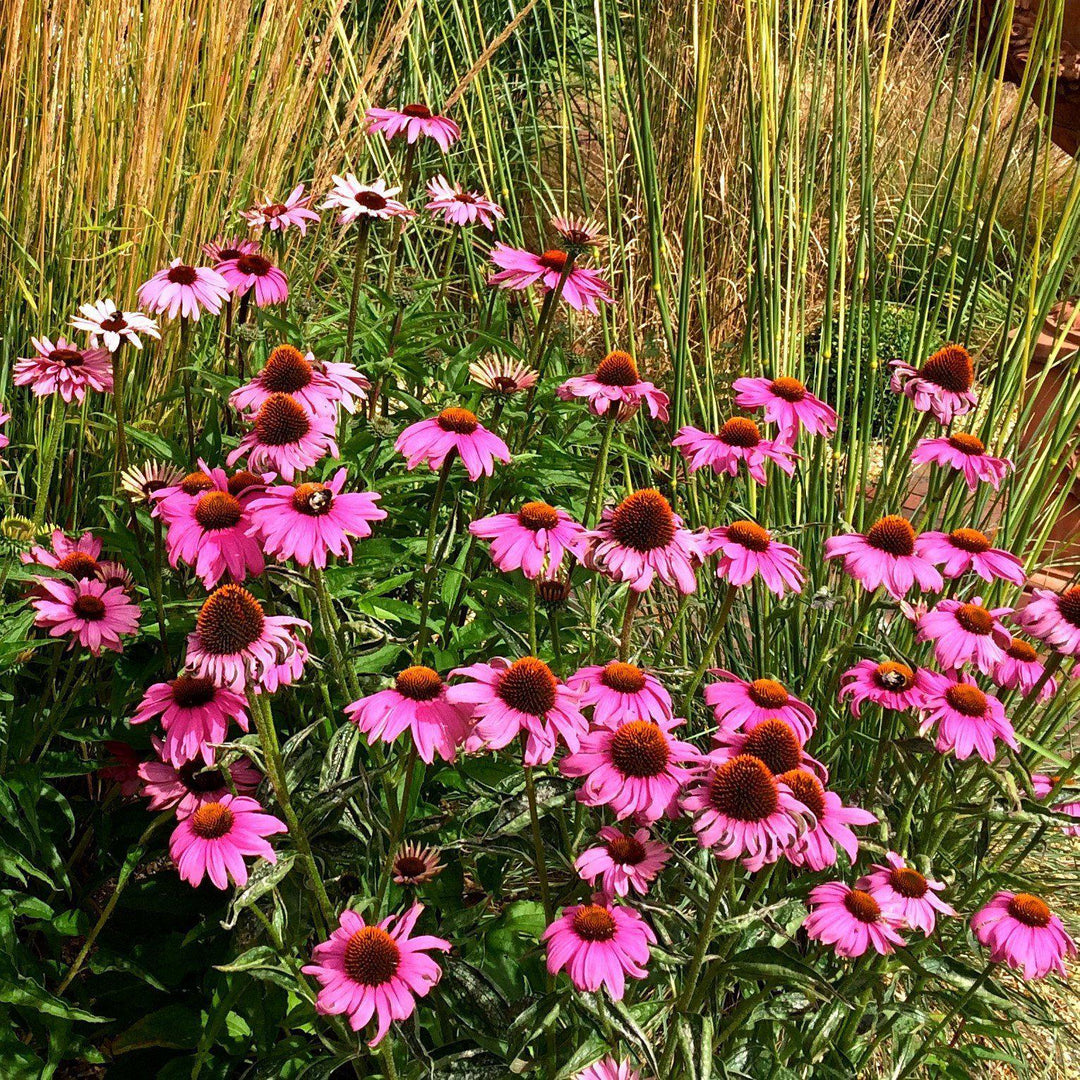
[543,894,657,1001]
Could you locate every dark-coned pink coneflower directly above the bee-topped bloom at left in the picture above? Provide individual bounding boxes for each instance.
[225,393,341,483]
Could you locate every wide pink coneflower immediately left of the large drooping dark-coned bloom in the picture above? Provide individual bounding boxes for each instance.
[558,718,700,823]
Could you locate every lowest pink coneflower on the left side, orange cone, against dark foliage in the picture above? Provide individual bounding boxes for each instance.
[168,794,288,889]
